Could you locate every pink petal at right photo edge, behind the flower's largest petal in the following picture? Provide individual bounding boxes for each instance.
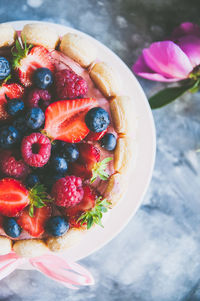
[178,36,200,67]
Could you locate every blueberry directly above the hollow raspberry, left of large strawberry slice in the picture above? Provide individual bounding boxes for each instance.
[26,108,45,130]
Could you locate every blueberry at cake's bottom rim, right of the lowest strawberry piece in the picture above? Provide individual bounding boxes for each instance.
[45,216,69,236]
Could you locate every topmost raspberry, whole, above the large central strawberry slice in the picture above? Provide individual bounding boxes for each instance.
[55,69,88,99]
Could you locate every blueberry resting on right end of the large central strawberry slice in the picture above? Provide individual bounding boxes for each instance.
[85,107,110,133]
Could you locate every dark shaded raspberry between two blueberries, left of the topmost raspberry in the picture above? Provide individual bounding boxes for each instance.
[26,89,52,110]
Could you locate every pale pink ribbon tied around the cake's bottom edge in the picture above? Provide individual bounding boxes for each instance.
[0,252,94,289]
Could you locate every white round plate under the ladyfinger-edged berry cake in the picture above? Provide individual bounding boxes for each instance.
[3,21,156,261]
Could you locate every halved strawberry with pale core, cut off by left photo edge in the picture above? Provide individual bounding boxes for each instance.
[0,178,29,216]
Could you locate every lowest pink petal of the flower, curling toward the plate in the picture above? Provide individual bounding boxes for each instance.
[132,55,179,82]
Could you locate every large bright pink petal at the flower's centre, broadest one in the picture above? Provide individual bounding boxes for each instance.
[143,41,193,80]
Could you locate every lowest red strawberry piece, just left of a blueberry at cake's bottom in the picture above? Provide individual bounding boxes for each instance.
[17,206,51,237]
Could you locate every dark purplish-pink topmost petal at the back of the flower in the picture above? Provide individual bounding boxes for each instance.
[172,22,200,40]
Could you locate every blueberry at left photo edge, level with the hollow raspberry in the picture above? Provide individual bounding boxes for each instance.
[0,125,20,148]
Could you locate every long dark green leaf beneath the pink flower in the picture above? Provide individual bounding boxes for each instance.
[149,82,199,109]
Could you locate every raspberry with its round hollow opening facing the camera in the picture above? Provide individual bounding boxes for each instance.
[21,133,51,167]
